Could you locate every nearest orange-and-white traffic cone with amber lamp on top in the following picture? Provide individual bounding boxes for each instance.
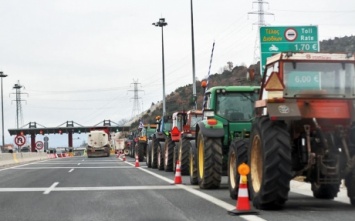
[228,163,258,215]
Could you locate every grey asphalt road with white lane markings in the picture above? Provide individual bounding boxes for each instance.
[0,156,355,221]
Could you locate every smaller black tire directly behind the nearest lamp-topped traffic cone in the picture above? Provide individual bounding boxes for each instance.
[228,139,249,199]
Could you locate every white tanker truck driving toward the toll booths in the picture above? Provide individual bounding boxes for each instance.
[86,130,111,158]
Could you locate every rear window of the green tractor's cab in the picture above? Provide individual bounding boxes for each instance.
[216,92,258,121]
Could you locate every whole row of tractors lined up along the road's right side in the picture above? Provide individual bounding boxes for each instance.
[126,53,355,209]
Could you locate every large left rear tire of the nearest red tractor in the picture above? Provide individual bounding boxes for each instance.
[248,116,292,210]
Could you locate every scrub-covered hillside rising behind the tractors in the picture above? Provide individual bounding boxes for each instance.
[131,36,355,128]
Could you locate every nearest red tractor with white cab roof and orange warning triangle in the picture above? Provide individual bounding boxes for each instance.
[242,52,355,209]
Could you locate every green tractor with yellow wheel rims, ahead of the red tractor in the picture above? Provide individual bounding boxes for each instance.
[190,86,260,192]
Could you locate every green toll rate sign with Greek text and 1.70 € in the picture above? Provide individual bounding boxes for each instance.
[260,26,319,73]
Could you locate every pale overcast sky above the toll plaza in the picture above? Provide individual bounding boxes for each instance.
[0,0,355,147]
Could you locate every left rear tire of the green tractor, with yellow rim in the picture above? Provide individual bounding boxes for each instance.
[197,131,222,189]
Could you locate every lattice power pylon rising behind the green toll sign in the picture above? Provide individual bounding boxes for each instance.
[248,0,274,64]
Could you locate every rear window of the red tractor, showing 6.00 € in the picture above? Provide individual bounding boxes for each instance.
[284,62,355,97]
